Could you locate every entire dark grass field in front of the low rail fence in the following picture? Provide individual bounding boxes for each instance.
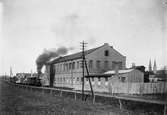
[0,82,163,115]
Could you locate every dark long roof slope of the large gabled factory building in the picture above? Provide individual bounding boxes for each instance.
[48,46,102,64]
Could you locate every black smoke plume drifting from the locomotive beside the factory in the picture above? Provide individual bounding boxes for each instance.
[36,47,68,75]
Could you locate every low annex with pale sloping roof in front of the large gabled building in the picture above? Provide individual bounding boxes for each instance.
[85,69,144,92]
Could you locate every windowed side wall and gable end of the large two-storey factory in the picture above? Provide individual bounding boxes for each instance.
[46,43,126,89]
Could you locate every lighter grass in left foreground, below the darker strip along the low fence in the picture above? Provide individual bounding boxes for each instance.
[0,81,125,115]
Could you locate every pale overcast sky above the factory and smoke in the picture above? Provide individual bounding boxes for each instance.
[0,0,167,74]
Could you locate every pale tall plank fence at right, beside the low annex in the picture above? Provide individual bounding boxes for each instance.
[109,82,167,94]
